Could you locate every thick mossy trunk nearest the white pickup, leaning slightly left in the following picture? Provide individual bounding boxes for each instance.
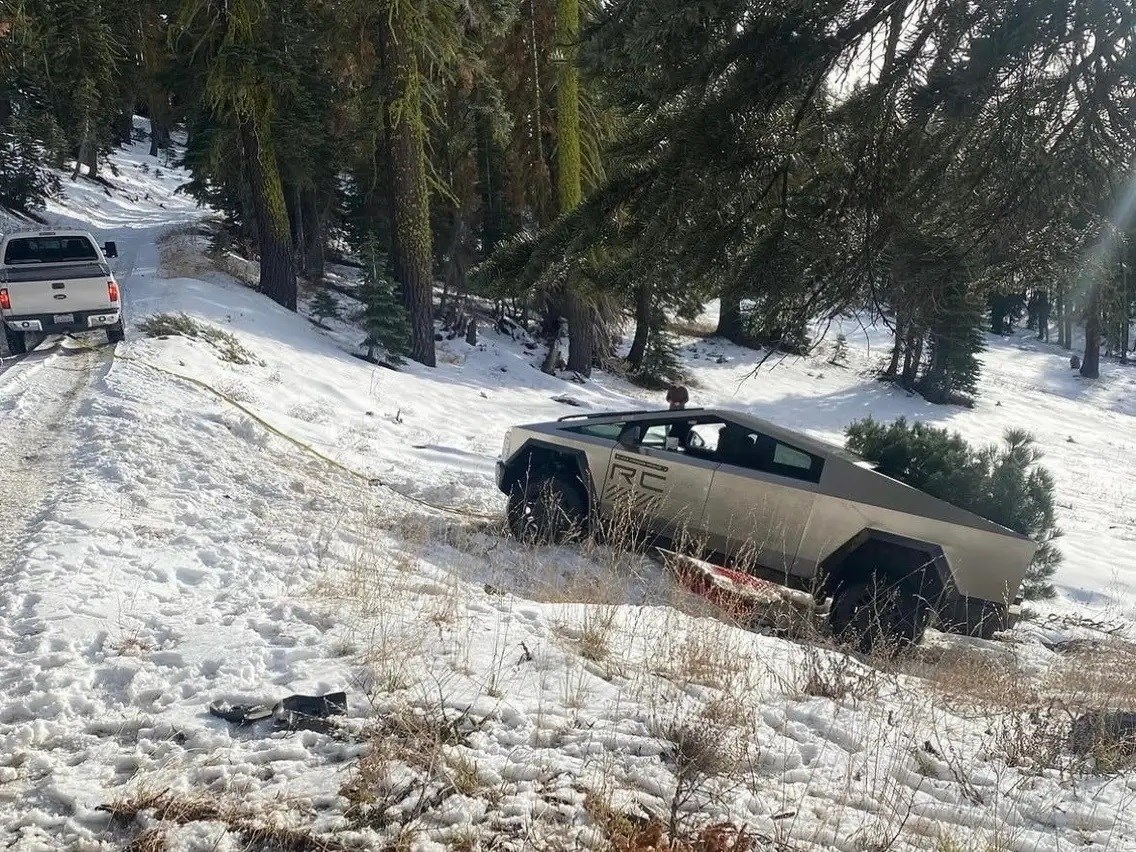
[239,116,296,310]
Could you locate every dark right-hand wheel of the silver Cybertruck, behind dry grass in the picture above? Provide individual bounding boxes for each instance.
[829,574,932,653]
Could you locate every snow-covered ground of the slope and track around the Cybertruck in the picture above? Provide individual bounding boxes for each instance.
[0,123,1136,852]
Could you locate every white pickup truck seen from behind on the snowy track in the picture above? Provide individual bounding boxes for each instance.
[0,231,125,354]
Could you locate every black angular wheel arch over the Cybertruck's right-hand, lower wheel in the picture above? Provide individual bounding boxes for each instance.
[818,528,954,598]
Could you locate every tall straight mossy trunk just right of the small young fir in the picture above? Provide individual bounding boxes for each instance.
[378,1,436,367]
